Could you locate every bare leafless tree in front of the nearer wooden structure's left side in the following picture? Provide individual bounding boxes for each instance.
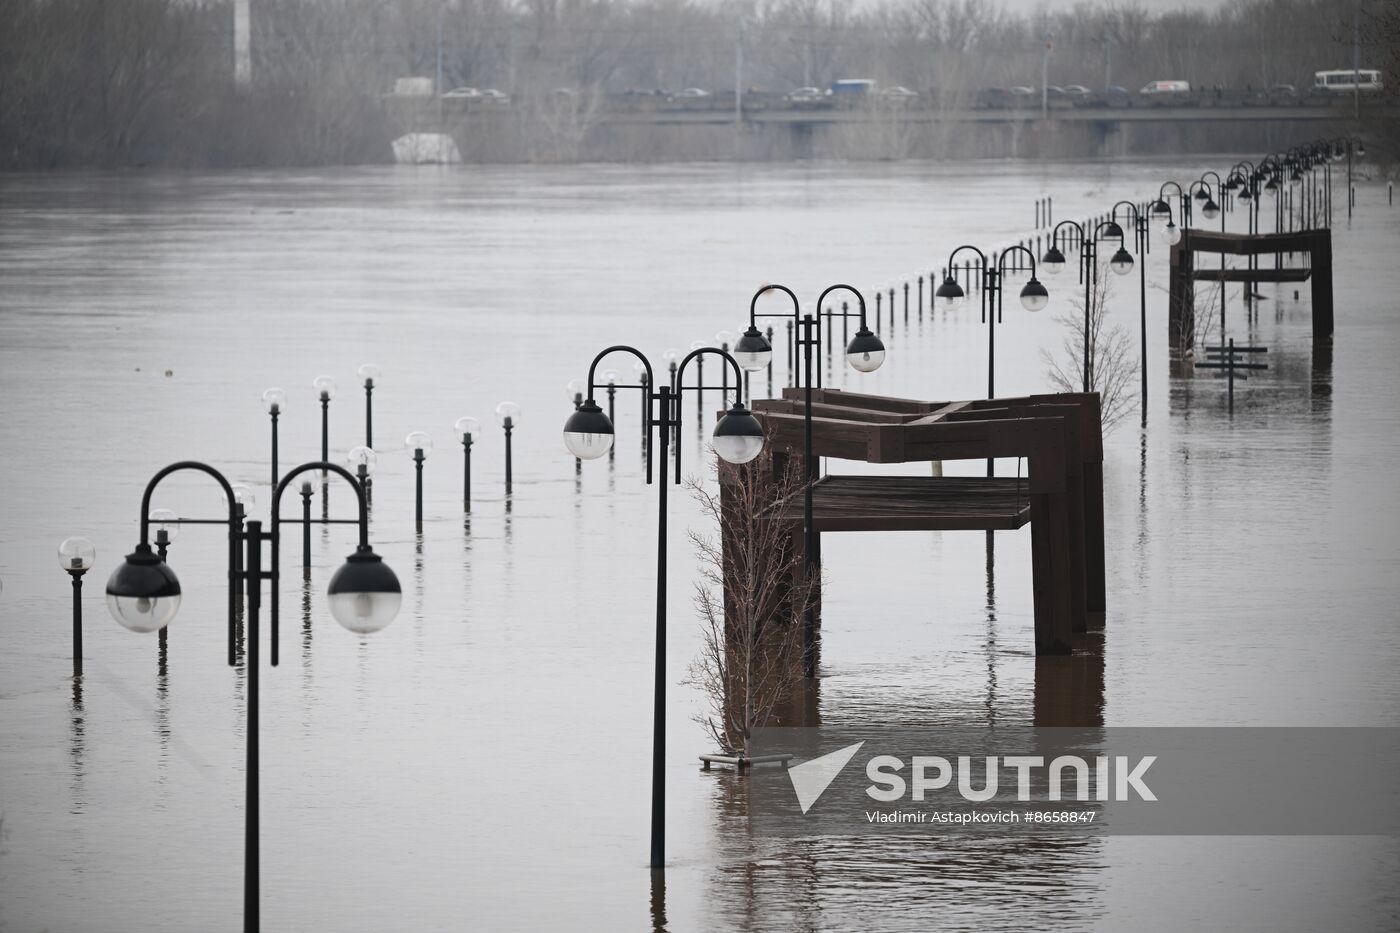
[686,454,820,755]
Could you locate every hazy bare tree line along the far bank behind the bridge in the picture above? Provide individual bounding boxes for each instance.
[0,0,1400,170]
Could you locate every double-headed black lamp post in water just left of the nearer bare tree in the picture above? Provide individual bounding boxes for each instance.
[564,345,763,869]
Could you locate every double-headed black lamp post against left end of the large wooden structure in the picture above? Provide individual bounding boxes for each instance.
[734,284,885,669]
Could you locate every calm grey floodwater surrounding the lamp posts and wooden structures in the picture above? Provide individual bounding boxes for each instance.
[0,163,1400,932]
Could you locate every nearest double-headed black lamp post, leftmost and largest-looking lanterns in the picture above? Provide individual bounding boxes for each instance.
[106,461,403,933]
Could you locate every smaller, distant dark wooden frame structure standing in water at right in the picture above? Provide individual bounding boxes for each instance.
[1168,227,1333,371]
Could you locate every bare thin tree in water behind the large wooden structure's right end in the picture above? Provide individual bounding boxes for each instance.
[1040,254,1138,431]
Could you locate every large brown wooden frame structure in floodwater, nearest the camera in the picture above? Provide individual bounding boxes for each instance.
[721,388,1105,654]
